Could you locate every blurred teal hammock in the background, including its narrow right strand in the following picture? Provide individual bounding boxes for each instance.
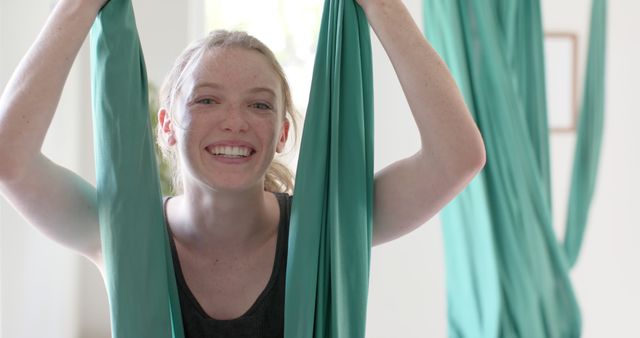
[424,0,606,338]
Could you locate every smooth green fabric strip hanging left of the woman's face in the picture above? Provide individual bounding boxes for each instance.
[91,0,184,338]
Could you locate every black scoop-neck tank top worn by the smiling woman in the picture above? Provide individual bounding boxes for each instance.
[165,193,291,338]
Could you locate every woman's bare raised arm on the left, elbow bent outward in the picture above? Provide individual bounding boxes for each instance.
[0,0,106,261]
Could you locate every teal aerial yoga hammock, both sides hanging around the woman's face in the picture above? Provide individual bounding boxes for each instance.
[91,0,373,338]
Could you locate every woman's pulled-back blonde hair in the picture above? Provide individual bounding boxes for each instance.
[156,30,298,193]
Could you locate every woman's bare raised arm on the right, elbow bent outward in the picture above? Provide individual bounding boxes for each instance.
[357,0,485,245]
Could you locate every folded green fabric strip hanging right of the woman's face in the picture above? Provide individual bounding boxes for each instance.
[285,0,373,338]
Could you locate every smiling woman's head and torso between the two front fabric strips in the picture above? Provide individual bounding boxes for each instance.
[158,31,294,336]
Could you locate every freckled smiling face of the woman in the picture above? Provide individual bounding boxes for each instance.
[171,48,288,191]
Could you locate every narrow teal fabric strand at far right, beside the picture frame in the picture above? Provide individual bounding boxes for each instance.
[564,0,607,267]
